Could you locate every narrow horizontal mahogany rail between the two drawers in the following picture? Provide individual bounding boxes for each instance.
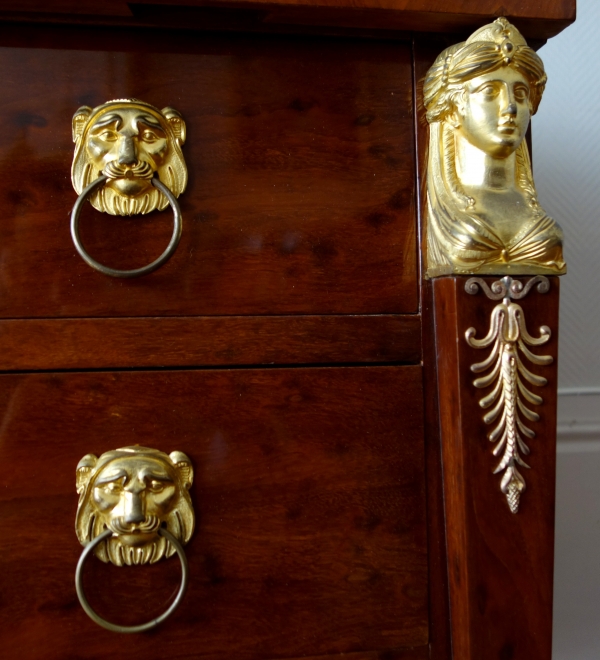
[0,315,421,371]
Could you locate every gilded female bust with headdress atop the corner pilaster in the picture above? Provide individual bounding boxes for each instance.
[423,18,566,277]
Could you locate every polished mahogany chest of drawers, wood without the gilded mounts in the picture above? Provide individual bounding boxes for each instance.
[0,2,573,660]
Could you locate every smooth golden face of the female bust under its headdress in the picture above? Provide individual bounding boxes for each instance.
[456,66,531,158]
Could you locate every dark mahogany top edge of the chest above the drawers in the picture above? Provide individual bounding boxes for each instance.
[0,0,575,39]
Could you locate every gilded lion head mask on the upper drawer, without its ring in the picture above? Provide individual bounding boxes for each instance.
[71,99,187,215]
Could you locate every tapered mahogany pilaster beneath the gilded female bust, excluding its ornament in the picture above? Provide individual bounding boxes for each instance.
[434,277,558,660]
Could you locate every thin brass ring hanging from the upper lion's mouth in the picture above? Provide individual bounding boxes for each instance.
[71,174,182,277]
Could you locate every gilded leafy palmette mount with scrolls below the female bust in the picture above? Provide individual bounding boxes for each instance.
[465,276,553,513]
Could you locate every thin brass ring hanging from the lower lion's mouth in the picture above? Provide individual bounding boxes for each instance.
[75,527,189,633]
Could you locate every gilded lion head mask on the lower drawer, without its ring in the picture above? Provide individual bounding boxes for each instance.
[75,446,194,566]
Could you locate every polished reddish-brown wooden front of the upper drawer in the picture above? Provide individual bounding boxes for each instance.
[0,27,417,318]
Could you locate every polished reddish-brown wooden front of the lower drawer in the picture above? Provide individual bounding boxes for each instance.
[0,366,428,660]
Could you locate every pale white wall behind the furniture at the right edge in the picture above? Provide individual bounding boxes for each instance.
[533,0,600,660]
